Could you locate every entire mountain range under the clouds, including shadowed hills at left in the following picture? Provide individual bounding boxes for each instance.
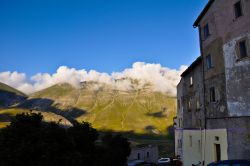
[0,80,176,139]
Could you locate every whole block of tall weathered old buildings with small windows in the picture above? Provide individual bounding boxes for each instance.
[176,0,250,165]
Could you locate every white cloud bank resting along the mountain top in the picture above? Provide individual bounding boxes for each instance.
[0,62,186,96]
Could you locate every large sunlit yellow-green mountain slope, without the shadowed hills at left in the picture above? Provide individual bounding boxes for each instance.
[29,82,176,135]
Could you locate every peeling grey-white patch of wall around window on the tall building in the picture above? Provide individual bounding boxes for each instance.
[223,33,250,116]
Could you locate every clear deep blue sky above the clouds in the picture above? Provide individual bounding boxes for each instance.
[0,0,207,76]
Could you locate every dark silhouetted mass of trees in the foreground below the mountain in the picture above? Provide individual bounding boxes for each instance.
[0,113,130,166]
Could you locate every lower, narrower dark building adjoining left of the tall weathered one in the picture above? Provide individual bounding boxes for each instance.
[175,57,205,164]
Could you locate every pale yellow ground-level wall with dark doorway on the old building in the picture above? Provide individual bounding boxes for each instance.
[183,129,228,166]
